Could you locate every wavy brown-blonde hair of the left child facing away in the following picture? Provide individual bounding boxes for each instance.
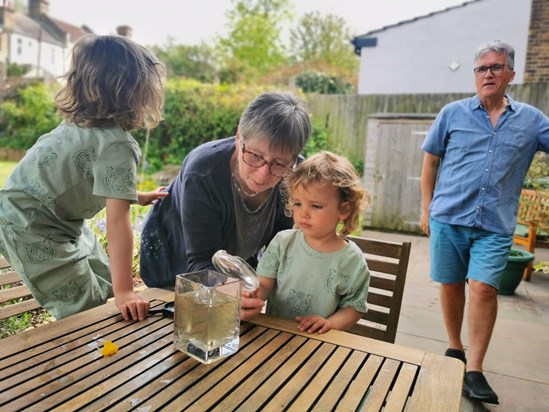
[55,35,165,131]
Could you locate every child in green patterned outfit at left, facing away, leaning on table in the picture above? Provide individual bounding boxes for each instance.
[0,35,166,320]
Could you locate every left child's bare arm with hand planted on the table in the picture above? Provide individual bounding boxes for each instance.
[107,199,149,320]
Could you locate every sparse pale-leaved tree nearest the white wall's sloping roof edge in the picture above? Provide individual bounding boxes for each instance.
[290,11,359,77]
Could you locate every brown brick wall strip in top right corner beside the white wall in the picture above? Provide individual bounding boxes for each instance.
[524,0,549,84]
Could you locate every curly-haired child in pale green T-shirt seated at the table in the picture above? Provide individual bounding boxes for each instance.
[257,151,370,333]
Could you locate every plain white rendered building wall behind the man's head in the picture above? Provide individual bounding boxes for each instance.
[358,0,531,94]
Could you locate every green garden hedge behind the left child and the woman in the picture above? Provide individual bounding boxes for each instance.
[0,79,328,172]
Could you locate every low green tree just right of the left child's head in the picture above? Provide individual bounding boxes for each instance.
[152,38,217,83]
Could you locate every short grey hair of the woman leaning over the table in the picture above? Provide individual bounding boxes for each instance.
[238,92,312,157]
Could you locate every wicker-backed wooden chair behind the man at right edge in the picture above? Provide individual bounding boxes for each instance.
[513,189,549,280]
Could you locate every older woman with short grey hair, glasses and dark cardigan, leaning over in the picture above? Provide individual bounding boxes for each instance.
[141,93,311,306]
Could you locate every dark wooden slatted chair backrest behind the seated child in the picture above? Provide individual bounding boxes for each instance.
[347,236,412,343]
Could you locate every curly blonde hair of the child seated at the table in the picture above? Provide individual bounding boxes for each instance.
[283,151,370,237]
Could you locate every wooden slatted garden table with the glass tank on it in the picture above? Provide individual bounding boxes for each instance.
[0,289,464,412]
